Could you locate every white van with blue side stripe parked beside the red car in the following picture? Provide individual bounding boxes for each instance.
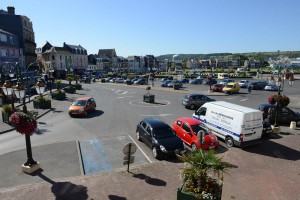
[193,101,263,147]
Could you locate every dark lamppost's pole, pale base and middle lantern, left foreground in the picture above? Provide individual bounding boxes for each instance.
[14,82,40,173]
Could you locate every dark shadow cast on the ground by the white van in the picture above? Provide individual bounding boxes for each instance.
[243,140,300,161]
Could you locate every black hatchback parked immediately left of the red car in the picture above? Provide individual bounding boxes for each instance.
[136,118,183,159]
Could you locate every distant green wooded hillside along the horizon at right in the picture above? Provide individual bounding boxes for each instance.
[157,51,300,61]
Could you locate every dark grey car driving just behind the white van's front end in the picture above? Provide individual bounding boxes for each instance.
[182,94,215,110]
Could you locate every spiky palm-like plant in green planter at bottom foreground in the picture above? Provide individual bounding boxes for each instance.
[177,149,232,200]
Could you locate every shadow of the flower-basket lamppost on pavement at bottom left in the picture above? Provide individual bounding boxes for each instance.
[31,169,88,200]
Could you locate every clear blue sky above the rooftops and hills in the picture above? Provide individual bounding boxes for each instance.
[0,0,300,57]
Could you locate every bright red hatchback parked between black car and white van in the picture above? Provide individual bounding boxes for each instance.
[173,117,220,150]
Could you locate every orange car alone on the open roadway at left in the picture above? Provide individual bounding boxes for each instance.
[68,97,96,117]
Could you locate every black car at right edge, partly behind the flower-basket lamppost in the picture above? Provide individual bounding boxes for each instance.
[258,104,300,127]
